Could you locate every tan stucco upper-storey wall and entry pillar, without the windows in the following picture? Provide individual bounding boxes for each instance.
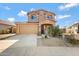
[28,10,56,33]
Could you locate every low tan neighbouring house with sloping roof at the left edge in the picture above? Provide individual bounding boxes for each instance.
[0,20,16,34]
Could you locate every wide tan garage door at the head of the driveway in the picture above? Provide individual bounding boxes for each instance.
[19,23,38,34]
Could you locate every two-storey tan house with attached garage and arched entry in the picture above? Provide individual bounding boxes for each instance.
[16,9,56,34]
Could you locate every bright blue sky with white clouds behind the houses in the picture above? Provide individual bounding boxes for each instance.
[0,3,79,27]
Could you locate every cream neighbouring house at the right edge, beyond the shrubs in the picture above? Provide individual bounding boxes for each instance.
[65,23,79,34]
